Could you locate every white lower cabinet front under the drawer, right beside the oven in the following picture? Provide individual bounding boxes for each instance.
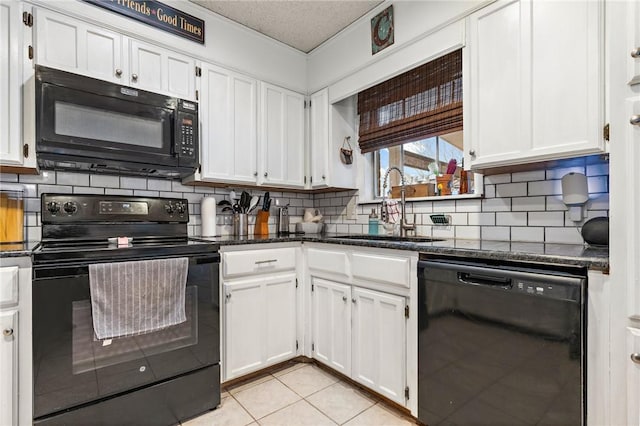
[223,272,296,380]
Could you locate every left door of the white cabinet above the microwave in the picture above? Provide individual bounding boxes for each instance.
[35,9,128,84]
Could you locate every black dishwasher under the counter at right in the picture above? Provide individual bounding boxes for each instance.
[418,255,586,426]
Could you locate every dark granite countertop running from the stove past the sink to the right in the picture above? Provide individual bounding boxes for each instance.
[200,234,609,270]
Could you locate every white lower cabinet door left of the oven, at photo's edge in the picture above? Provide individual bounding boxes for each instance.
[0,310,17,425]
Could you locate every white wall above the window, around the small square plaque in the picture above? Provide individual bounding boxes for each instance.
[307,0,489,96]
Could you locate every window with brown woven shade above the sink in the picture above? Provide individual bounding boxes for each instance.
[358,50,472,197]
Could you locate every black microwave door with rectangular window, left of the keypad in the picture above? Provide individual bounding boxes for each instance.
[36,71,178,166]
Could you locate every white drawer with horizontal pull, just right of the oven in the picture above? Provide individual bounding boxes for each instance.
[222,247,296,278]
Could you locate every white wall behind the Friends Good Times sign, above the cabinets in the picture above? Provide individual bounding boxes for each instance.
[31,0,307,93]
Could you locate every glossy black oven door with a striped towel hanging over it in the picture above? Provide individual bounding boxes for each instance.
[33,254,220,419]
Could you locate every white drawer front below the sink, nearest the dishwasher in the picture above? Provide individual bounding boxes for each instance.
[351,253,410,287]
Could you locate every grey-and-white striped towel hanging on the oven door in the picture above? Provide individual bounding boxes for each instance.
[89,257,189,339]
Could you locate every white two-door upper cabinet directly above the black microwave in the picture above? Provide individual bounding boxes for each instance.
[35,9,196,100]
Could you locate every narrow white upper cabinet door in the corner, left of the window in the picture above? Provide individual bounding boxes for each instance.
[309,89,329,188]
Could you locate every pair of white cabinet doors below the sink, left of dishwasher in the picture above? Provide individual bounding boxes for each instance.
[311,276,406,405]
